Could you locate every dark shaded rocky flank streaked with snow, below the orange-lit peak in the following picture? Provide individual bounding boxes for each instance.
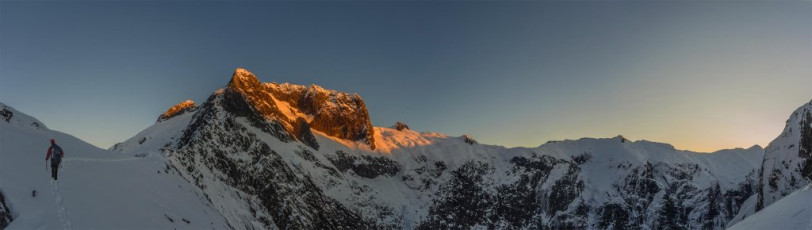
[169,90,379,229]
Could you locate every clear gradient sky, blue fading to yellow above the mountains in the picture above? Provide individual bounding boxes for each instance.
[0,1,812,152]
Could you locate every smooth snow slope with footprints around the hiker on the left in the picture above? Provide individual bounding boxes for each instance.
[0,103,228,229]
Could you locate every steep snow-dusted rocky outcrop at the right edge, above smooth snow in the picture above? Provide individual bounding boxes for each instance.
[756,101,812,211]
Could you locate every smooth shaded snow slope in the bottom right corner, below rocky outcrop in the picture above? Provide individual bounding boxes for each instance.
[729,185,812,230]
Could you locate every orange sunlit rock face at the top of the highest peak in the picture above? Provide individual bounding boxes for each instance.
[222,68,375,149]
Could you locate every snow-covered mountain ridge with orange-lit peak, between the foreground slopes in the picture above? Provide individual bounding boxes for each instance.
[106,69,764,229]
